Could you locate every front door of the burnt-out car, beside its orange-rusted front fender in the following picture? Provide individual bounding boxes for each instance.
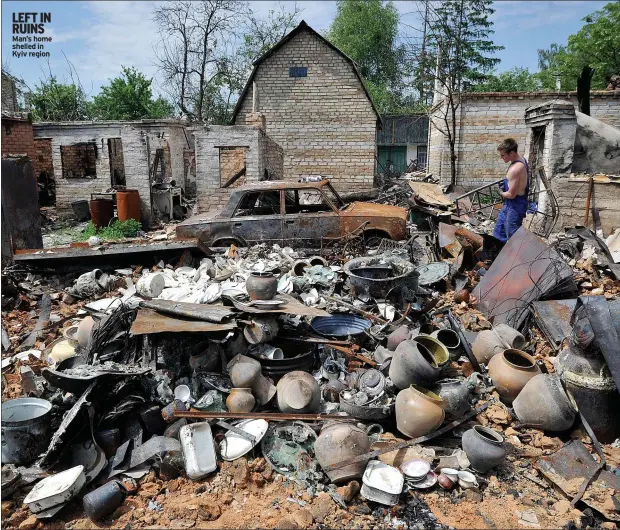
[283,188,340,245]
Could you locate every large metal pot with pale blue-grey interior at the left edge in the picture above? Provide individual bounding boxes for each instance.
[0,398,52,465]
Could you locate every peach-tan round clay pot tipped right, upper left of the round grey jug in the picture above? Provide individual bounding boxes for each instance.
[395,385,445,438]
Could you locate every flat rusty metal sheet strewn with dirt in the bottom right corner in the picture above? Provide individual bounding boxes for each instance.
[537,440,620,521]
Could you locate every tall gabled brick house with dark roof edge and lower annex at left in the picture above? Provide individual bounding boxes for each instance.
[195,21,380,211]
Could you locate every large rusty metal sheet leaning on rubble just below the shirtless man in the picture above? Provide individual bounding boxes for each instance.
[472,227,576,329]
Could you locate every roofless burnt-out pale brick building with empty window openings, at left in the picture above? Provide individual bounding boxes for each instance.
[34,120,193,222]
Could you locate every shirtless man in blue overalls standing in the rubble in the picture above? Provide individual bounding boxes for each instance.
[493,138,530,243]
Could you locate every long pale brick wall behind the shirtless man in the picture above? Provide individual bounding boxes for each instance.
[429,91,620,188]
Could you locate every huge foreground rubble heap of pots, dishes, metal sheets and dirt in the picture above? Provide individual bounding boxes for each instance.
[1,188,620,529]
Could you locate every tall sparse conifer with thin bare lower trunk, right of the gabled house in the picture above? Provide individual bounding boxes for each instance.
[421,0,503,185]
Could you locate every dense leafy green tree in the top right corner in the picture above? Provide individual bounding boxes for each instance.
[538,2,620,90]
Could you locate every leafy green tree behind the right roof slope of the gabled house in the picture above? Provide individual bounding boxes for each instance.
[327,0,406,113]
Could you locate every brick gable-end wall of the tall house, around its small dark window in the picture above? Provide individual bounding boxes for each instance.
[235,30,377,190]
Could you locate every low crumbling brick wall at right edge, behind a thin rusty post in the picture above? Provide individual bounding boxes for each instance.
[551,177,620,236]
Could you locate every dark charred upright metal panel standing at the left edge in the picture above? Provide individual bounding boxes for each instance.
[2,158,43,249]
